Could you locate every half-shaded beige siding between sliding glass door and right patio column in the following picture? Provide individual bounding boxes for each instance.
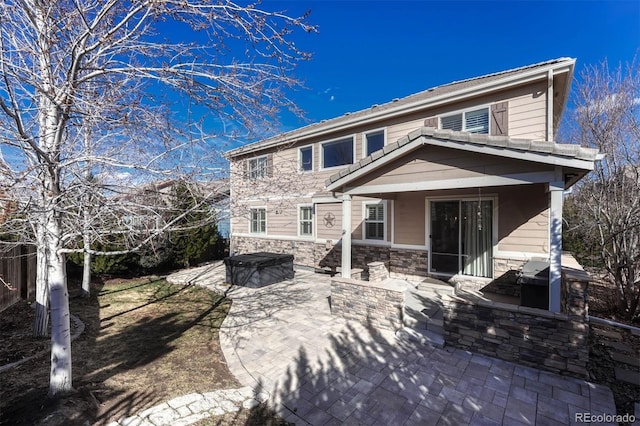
[498,184,549,255]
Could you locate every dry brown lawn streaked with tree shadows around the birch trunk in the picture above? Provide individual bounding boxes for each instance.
[0,282,233,425]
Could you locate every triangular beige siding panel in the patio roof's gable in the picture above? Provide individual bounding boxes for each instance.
[350,146,550,187]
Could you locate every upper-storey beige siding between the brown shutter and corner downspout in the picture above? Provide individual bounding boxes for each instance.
[509,83,547,139]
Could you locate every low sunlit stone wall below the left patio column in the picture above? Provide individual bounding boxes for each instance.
[331,276,404,332]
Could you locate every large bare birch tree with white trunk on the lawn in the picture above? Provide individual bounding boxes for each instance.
[0,0,314,396]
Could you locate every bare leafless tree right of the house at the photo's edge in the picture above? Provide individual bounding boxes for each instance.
[569,61,640,320]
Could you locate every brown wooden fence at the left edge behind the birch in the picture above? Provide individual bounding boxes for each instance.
[0,246,36,311]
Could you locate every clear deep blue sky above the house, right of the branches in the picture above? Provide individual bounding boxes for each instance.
[270,0,640,130]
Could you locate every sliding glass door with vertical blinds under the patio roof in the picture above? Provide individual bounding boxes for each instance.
[430,200,493,278]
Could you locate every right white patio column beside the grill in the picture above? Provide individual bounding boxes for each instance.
[549,182,564,312]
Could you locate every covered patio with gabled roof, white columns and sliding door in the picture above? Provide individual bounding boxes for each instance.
[326,127,600,313]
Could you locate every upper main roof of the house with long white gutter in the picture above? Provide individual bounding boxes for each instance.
[226,58,575,157]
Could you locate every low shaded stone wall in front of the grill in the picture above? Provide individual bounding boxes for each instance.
[444,266,589,378]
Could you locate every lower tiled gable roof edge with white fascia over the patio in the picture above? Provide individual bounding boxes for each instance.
[325,127,602,191]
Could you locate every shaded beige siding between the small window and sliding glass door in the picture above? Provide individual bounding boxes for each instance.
[393,192,426,245]
